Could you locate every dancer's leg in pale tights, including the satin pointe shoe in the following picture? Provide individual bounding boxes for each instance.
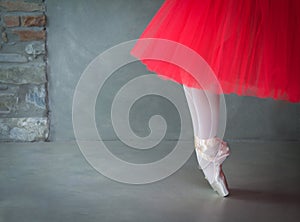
[183,85,229,196]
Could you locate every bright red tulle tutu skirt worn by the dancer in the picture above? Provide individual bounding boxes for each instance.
[131,0,300,102]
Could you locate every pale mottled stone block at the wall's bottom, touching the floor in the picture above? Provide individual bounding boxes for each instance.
[0,117,49,142]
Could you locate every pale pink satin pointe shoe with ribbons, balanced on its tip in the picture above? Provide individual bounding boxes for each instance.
[195,136,229,197]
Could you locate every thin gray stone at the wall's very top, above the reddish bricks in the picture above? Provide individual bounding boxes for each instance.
[0,1,45,12]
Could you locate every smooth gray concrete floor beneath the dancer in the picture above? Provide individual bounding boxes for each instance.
[0,141,300,222]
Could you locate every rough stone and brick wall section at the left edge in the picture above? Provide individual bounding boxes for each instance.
[0,0,49,141]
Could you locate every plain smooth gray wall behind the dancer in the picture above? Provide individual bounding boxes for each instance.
[47,0,300,141]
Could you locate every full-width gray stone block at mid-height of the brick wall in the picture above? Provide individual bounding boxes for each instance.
[0,63,46,84]
